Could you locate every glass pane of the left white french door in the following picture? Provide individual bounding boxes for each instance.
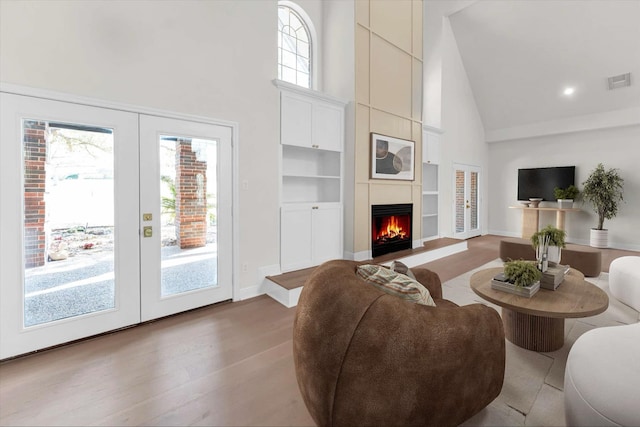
[22,119,115,327]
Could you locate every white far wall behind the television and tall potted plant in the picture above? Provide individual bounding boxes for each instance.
[489,126,640,250]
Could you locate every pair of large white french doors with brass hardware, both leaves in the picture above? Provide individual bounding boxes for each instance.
[0,93,232,359]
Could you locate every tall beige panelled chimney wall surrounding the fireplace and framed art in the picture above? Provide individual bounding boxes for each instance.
[353,0,423,258]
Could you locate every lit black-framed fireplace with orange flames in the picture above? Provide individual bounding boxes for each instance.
[371,203,413,258]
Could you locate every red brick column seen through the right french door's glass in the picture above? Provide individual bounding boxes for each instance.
[176,139,207,249]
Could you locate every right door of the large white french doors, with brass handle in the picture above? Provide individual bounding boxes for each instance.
[140,116,232,320]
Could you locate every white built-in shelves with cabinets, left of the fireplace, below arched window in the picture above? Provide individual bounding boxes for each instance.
[276,82,345,272]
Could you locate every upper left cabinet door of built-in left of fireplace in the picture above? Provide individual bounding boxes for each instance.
[280,93,313,147]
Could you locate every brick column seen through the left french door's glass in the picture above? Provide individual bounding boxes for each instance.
[23,121,47,268]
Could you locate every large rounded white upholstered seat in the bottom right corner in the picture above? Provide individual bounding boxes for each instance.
[564,323,640,426]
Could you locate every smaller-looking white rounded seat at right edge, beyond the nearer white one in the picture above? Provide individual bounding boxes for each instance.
[609,256,640,312]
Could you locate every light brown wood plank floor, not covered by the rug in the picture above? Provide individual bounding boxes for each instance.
[0,236,640,426]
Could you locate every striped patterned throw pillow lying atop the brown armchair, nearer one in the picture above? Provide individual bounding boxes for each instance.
[357,264,436,307]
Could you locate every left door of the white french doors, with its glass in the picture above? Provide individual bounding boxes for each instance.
[0,93,140,358]
